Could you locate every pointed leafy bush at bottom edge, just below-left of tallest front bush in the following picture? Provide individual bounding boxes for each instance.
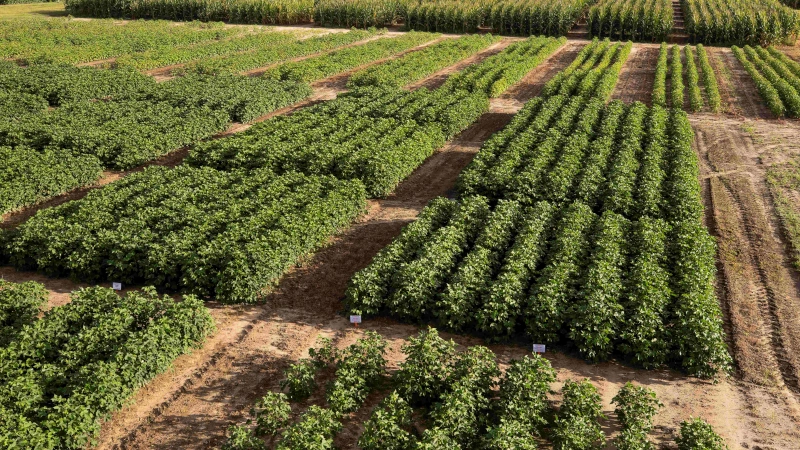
[358,391,415,450]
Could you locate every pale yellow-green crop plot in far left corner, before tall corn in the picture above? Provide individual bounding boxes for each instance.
[0,18,242,64]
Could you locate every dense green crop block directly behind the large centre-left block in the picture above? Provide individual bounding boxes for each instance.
[187,88,489,197]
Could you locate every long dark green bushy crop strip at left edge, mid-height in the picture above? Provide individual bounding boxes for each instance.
[0,64,311,212]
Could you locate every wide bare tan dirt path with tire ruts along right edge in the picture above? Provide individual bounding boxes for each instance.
[691,115,800,448]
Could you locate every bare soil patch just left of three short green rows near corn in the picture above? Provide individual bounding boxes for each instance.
[611,46,659,106]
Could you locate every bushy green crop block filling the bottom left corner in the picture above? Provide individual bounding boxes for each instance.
[0,283,214,449]
